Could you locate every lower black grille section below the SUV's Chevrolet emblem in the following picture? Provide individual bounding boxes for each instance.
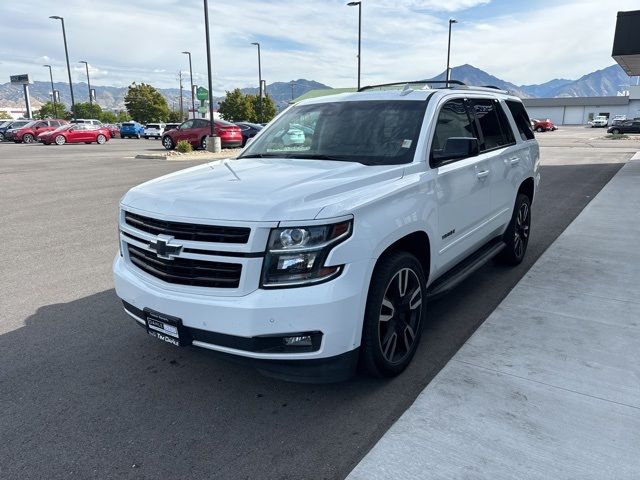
[127,244,242,288]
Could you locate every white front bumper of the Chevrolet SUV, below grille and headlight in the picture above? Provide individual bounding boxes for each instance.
[113,255,370,376]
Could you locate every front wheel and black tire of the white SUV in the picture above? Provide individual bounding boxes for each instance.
[360,252,426,377]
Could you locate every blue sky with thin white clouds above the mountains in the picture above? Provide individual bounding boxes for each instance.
[0,0,640,93]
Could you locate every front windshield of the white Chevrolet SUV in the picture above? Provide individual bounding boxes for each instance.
[239,100,426,165]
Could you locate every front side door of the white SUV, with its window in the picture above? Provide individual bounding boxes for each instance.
[430,98,491,270]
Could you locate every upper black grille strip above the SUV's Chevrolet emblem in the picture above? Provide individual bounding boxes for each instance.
[124,212,251,243]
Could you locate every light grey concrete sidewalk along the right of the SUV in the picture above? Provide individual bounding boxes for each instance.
[348,154,640,480]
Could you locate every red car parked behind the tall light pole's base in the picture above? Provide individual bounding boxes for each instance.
[162,118,242,150]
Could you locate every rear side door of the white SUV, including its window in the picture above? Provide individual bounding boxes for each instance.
[470,97,522,230]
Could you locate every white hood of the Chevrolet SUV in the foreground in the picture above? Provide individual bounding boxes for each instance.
[122,158,404,222]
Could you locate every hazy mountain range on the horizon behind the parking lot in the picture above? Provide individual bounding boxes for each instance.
[0,64,630,110]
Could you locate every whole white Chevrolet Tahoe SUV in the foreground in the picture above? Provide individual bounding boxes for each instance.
[113,82,539,381]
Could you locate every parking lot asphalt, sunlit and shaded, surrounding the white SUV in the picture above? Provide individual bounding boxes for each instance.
[0,128,638,479]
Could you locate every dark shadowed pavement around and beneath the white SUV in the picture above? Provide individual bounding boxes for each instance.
[0,164,620,480]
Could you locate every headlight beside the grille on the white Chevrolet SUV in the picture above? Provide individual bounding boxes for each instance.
[261,220,353,288]
